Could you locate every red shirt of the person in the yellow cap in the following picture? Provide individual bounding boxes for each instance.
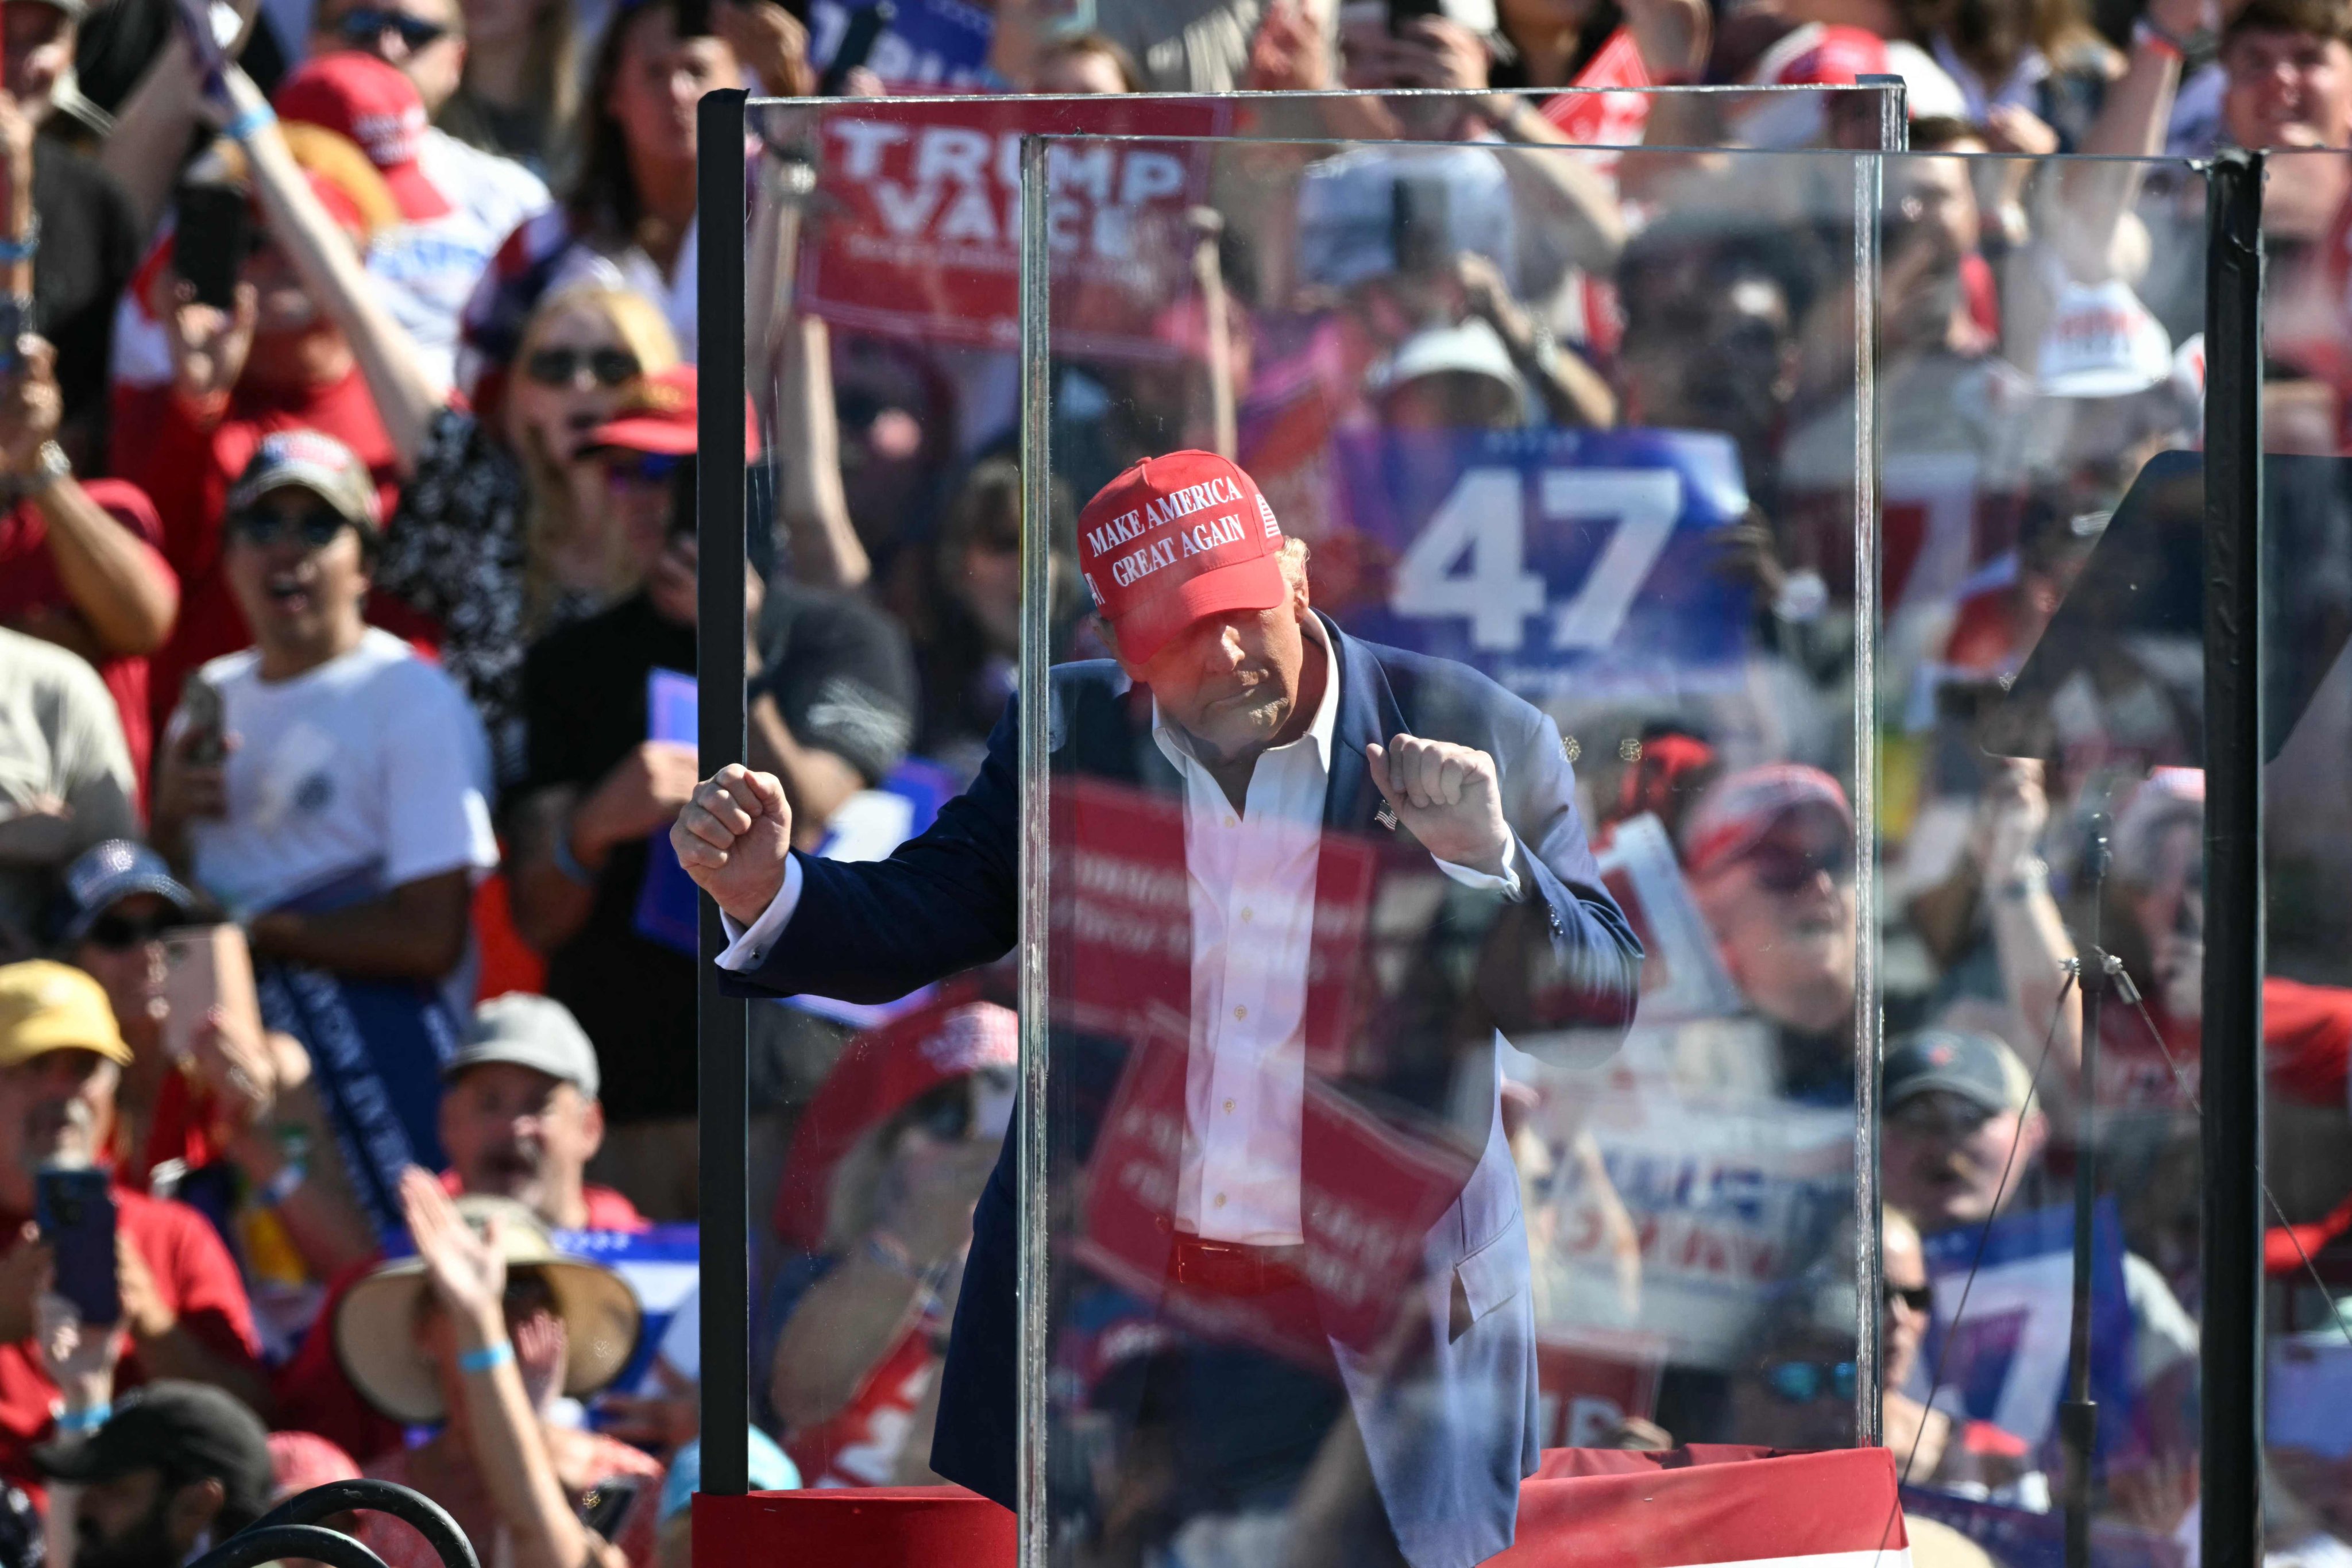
[0,1187,261,1488]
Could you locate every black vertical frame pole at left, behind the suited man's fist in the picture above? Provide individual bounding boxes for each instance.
[694,87,750,1497]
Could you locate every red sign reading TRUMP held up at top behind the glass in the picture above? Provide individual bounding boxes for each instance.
[800,96,1228,360]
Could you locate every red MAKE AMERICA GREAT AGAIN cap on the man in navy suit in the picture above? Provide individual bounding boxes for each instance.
[1077,451,1291,665]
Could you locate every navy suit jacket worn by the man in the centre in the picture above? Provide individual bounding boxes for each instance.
[722,621,1642,1568]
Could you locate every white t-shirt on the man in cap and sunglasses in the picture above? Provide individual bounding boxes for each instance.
[174,628,499,912]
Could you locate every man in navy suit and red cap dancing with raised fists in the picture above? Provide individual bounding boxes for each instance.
[670,451,1642,1568]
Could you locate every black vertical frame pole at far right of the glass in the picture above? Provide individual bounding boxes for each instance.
[2199,153,2265,1568]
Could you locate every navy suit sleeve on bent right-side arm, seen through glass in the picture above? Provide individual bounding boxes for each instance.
[1480,703,1642,1048]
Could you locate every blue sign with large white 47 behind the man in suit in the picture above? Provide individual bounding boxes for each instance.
[1317,430,1752,698]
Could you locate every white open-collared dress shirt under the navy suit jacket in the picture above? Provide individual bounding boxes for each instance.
[720,616,1519,1246]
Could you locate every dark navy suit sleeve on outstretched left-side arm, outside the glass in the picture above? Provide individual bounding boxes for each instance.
[720,703,1021,1004]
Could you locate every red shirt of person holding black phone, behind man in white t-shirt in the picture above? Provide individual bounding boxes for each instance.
[115,369,404,731]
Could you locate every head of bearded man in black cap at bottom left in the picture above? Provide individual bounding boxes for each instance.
[35,1382,271,1568]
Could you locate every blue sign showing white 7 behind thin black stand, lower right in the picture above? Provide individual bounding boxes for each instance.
[1926,1199,2135,1455]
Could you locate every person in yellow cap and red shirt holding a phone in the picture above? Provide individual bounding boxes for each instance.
[0,959,268,1481]
